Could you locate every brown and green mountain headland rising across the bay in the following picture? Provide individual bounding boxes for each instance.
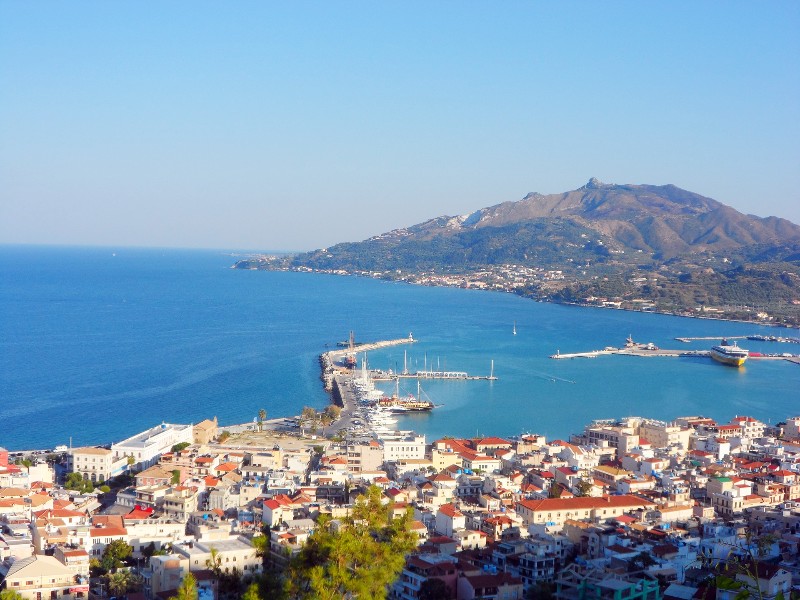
[237,178,800,322]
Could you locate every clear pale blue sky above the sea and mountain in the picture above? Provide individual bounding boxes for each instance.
[0,0,800,250]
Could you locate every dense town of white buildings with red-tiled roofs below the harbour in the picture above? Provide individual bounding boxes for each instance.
[0,416,800,600]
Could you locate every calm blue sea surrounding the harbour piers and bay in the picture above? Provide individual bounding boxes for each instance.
[0,245,800,451]
